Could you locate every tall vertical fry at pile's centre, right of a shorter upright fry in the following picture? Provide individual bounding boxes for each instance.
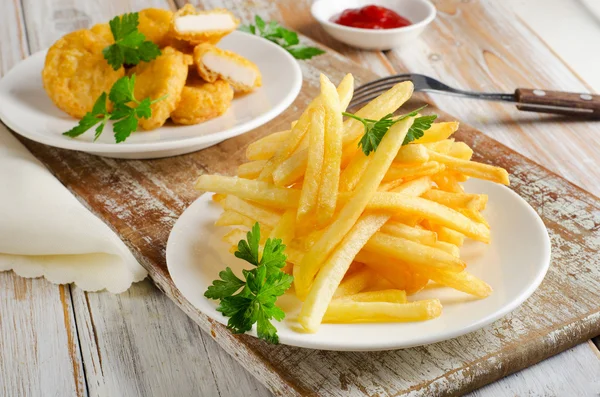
[316,74,343,226]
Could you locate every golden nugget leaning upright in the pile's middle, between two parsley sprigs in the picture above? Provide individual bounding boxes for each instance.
[129,47,188,130]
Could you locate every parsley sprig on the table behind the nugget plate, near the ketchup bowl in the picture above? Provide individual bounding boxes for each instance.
[239,15,325,59]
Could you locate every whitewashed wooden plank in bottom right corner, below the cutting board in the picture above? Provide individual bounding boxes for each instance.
[466,342,600,397]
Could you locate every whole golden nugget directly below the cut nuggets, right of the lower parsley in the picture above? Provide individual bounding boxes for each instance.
[171,78,233,125]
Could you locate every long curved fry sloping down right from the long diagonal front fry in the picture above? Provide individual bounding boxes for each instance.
[369,192,490,243]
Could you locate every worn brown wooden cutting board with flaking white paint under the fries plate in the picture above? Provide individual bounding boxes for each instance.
[15,26,600,396]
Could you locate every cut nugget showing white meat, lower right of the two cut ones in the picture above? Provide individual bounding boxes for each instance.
[194,43,262,92]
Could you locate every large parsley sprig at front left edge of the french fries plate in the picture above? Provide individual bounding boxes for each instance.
[204,222,294,343]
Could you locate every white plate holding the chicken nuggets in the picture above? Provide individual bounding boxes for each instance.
[0,31,302,159]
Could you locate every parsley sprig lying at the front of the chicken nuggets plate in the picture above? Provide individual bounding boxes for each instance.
[63,74,166,143]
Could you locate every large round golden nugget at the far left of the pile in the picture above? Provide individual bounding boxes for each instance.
[42,24,125,118]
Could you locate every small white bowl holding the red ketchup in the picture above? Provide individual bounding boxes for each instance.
[311,0,436,50]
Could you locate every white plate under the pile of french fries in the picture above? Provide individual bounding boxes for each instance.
[167,180,550,351]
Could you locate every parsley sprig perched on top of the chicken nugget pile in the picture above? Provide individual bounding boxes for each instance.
[102,12,160,70]
